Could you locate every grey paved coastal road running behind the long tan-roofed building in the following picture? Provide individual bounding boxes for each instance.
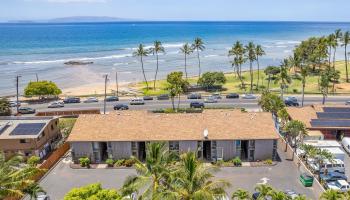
[13,96,350,111]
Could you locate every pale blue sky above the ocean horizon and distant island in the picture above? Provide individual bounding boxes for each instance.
[0,0,350,22]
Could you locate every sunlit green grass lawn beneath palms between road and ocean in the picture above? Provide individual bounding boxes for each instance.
[135,61,350,95]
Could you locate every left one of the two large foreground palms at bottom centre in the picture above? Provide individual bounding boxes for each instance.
[122,142,175,199]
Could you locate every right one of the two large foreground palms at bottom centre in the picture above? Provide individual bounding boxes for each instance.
[167,152,229,200]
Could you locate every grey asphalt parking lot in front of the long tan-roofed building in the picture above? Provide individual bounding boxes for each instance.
[34,148,319,200]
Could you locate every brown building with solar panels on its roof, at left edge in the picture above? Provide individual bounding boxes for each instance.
[0,117,61,158]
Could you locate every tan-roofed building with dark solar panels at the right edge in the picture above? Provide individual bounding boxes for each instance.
[287,106,350,140]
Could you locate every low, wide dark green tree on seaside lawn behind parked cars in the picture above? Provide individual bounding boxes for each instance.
[198,72,226,90]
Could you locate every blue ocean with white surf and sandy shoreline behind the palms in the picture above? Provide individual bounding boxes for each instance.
[0,22,350,96]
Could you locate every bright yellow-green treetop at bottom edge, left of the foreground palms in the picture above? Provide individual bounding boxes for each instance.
[64,183,122,200]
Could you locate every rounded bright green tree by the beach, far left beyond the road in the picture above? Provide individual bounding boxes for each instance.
[24,81,62,99]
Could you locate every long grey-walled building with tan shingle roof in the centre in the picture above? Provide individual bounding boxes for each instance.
[68,110,279,163]
